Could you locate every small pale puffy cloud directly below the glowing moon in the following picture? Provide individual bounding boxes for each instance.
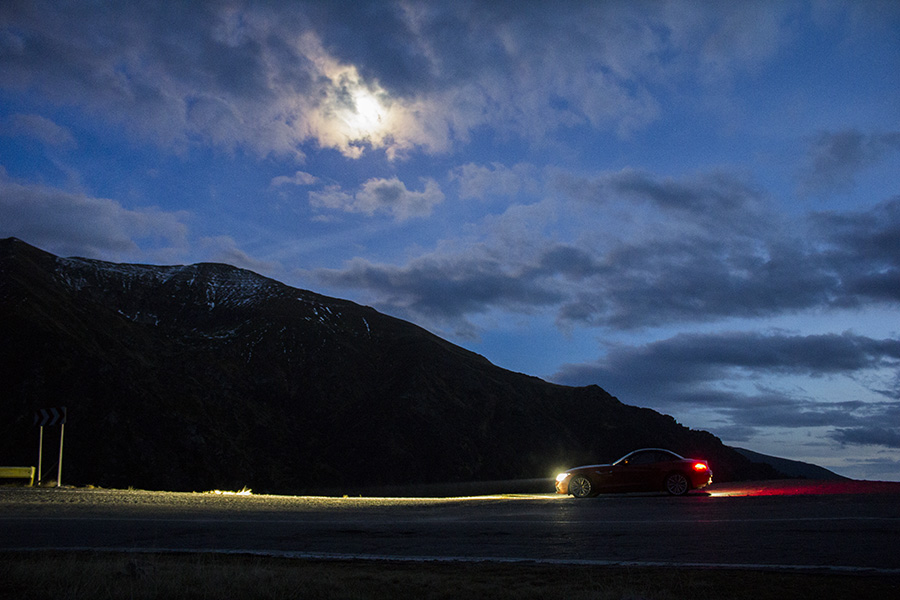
[309,177,444,221]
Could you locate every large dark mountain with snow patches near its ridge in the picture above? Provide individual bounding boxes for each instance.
[0,238,777,493]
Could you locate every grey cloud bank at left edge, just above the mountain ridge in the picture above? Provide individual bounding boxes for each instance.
[0,172,188,260]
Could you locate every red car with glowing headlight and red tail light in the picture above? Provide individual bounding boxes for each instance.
[556,448,712,498]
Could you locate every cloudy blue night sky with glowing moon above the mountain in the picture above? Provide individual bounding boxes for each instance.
[0,0,900,480]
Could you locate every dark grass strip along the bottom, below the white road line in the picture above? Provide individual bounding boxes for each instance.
[0,552,900,600]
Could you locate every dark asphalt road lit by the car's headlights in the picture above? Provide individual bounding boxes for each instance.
[0,485,900,574]
